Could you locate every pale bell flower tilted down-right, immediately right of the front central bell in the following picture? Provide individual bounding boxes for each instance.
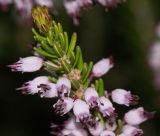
[99,96,115,117]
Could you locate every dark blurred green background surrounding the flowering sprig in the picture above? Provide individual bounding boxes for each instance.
[0,0,160,136]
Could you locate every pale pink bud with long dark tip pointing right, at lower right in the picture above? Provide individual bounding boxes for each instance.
[124,107,154,125]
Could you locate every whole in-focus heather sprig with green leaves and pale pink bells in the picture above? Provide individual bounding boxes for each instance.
[9,6,153,136]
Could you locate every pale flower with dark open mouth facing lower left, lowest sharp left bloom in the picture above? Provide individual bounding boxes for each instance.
[53,97,73,116]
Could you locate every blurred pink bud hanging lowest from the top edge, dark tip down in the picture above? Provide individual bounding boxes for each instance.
[64,0,80,25]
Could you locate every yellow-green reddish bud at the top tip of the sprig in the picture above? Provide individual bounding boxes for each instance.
[32,6,52,33]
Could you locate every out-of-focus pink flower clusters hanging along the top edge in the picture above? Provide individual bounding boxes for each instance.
[0,0,125,25]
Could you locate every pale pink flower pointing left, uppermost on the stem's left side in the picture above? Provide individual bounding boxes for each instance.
[8,56,43,72]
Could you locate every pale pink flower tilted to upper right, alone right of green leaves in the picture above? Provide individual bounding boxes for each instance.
[92,58,113,77]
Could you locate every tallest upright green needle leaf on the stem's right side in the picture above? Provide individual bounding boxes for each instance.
[67,33,77,58]
